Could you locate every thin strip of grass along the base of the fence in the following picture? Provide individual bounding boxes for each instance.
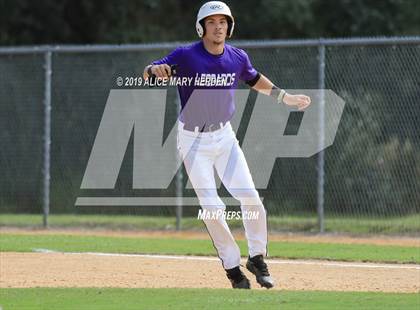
[0,214,420,235]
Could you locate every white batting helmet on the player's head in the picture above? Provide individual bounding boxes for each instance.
[195,1,235,38]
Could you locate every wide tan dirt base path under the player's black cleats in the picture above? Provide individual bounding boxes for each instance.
[0,252,420,293]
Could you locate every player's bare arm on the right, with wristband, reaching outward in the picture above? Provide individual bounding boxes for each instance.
[248,73,311,110]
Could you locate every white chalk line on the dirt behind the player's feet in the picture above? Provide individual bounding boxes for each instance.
[33,249,420,270]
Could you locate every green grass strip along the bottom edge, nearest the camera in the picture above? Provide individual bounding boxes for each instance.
[0,288,420,310]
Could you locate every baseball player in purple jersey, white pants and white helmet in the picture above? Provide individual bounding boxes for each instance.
[143,1,310,289]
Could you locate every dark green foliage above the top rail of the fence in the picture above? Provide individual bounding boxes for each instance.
[0,0,420,45]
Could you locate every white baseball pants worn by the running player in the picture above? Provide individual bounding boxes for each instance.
[177,122,267,269]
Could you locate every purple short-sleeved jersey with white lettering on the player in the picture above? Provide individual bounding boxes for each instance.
[152,41,258,126]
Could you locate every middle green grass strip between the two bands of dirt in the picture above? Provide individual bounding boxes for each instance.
[0,233,420,263]
